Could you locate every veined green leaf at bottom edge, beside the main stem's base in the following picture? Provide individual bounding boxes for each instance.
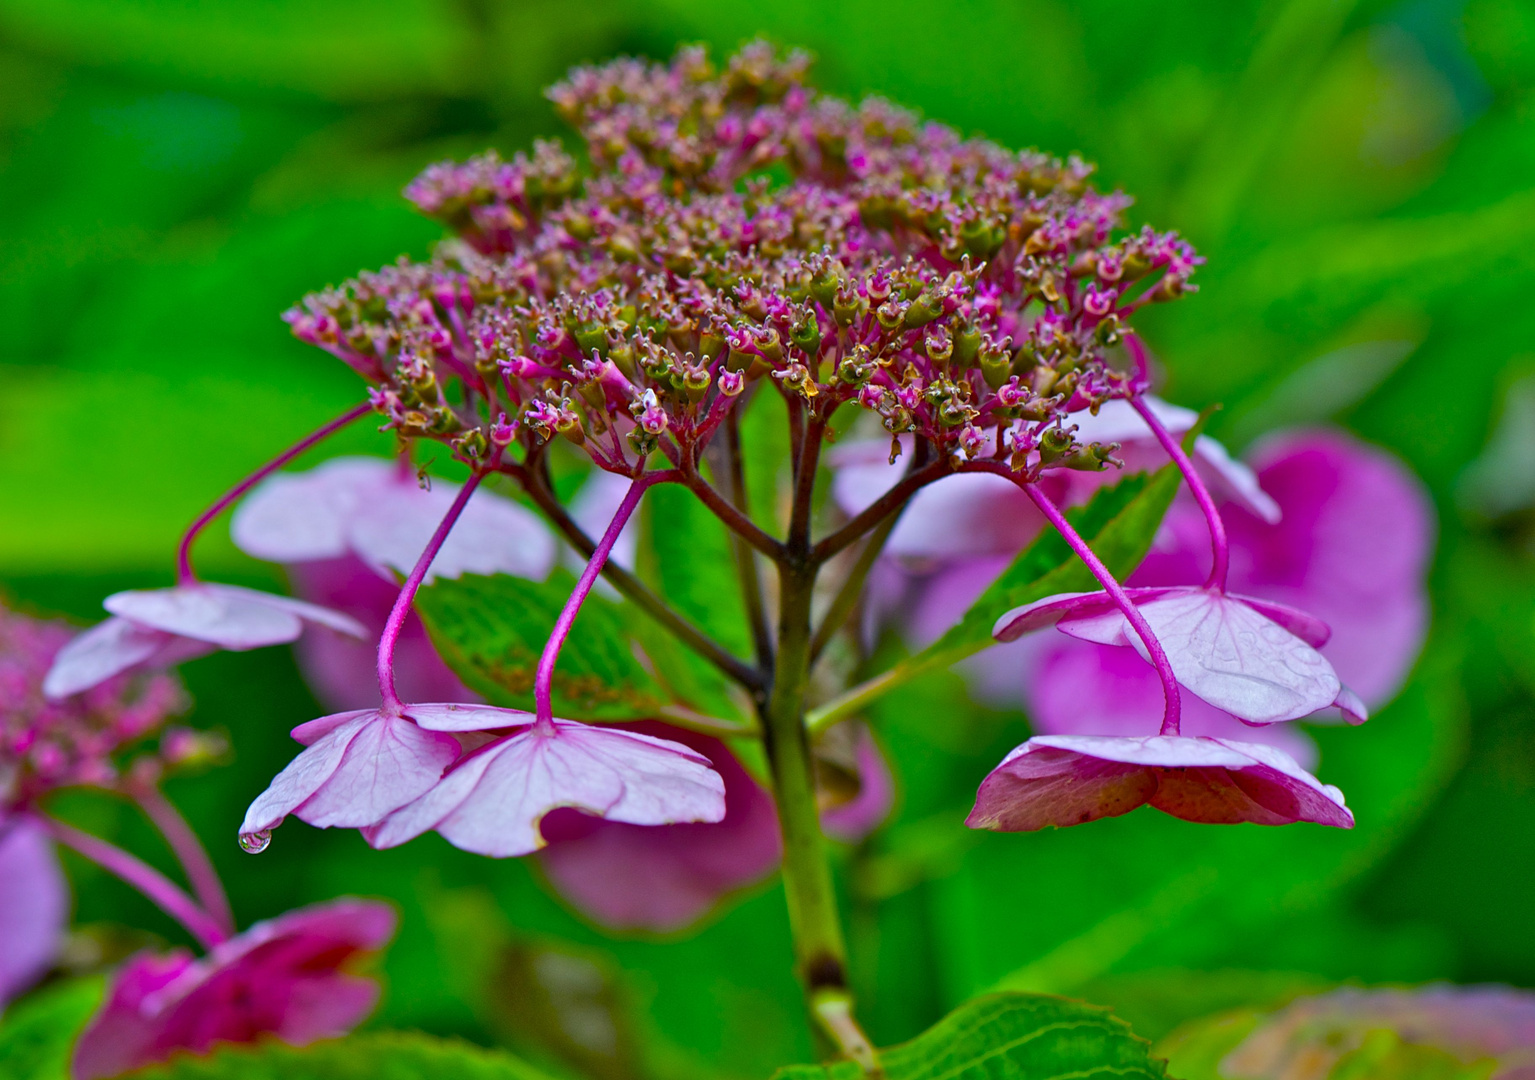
[775,994,1165,1080]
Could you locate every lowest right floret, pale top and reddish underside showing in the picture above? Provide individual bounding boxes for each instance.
[966,735,1354,831]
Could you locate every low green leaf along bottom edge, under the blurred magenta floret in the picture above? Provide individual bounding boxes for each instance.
[132,1032,548,1080]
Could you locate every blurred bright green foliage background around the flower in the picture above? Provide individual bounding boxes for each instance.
[0,0,1535,1078]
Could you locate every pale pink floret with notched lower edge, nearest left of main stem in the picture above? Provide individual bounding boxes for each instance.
[365,719,725,858]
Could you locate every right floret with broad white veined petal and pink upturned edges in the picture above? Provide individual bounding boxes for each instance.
[993,586,1366,724]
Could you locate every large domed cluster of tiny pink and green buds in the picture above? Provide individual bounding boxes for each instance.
[287,43,1202,473]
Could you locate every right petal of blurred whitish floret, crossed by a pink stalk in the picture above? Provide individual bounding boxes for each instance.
[348,480,556,581]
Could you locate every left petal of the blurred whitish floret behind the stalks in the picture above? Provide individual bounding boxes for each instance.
[229,457,396,563]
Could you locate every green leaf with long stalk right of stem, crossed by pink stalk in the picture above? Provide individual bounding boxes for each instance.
[807,465,1180,729]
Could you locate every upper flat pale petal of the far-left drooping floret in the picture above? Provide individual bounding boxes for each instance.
[103,584,304,650]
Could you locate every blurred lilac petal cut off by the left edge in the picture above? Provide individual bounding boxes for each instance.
[0,816,69,1011]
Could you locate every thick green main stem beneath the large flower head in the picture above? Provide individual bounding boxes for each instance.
[763,561,878,1072]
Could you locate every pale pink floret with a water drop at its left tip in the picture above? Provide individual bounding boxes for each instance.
[239,709,459,836]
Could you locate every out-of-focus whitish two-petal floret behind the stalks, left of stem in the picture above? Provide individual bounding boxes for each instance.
[230,457,556,581]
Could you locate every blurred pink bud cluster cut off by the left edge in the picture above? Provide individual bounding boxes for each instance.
[0,608,191,808]
